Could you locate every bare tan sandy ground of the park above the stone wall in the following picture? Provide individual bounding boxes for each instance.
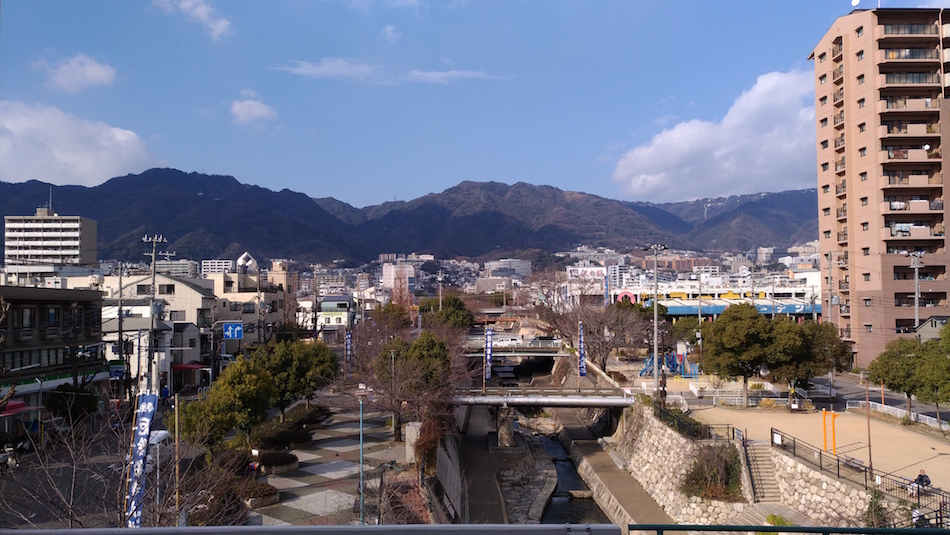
[691,407,950,490]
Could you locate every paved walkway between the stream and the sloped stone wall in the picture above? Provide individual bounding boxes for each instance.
[549,409,674,530]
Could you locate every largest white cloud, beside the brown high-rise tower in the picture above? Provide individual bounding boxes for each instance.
[613,71,817,202]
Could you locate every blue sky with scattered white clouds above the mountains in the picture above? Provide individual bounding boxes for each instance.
[0,0,950,207]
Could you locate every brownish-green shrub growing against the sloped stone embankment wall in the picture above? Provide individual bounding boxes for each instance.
[680,444,742,502]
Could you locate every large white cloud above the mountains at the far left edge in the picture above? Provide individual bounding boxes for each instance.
[0,100,157,186]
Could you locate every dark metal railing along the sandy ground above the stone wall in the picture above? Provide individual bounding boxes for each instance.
[771,427,950,526]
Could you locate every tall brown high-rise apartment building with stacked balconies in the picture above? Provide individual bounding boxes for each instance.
[809,9,950,367]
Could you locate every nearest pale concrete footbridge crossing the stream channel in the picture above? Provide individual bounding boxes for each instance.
[452,386,635,407]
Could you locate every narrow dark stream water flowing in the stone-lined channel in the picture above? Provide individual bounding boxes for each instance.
[539,436,610,524]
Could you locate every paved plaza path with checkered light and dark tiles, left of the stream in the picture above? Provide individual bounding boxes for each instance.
[249,412,406,526]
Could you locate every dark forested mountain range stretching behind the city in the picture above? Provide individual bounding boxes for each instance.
[0,169,818,265]
